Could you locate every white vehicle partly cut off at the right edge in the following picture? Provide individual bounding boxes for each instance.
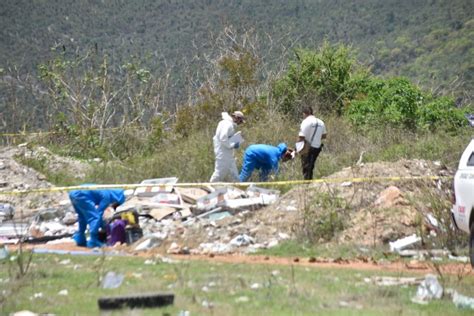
[451,139,474,267]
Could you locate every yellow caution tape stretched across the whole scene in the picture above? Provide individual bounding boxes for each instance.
[0,176,453,195]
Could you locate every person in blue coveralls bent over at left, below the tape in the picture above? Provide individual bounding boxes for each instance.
[69,189,125,248]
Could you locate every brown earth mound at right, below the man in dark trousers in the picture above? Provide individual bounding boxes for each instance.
[279,159,453,246]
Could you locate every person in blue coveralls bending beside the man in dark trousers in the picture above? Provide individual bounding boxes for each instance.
[239,143,293,182]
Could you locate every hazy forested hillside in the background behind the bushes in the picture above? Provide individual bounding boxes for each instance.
[0,0,474,99]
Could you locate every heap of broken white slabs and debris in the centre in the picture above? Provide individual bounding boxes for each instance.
[117,178,289,254]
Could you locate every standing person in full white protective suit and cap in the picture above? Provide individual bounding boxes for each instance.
[209,111,245,182]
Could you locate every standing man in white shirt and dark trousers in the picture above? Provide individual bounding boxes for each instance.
[298,107,327,180]
